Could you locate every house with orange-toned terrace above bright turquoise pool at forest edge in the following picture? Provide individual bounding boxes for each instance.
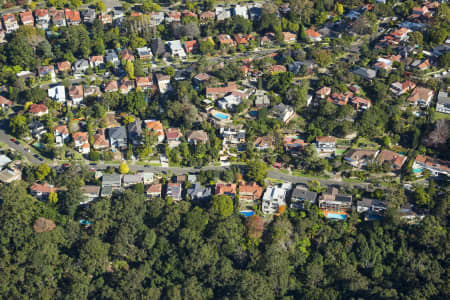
[318,187,352,219]
